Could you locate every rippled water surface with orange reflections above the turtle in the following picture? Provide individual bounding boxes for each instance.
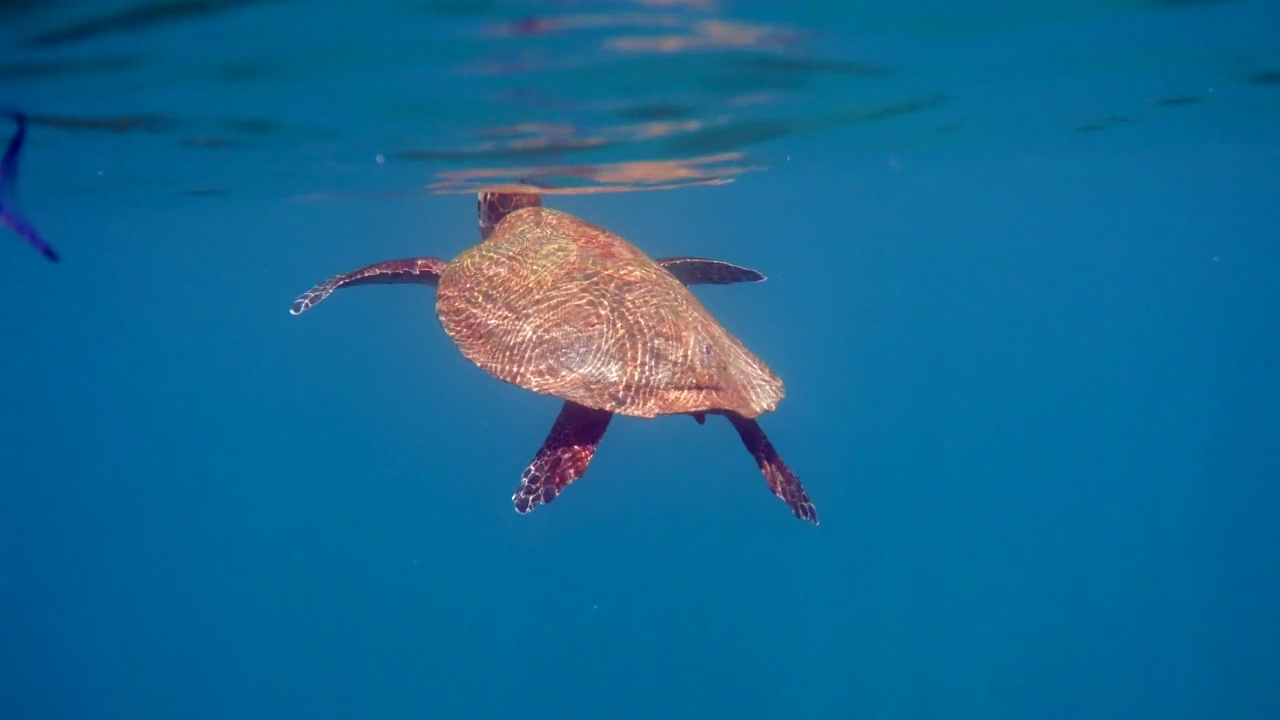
[0,0,1277,199]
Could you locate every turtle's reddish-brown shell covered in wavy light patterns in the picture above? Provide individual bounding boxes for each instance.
[435,208,783,418]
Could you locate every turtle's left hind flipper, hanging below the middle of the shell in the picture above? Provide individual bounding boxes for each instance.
[511,401,613,515]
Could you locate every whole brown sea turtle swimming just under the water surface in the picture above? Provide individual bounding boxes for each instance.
[289,191,818,524]
